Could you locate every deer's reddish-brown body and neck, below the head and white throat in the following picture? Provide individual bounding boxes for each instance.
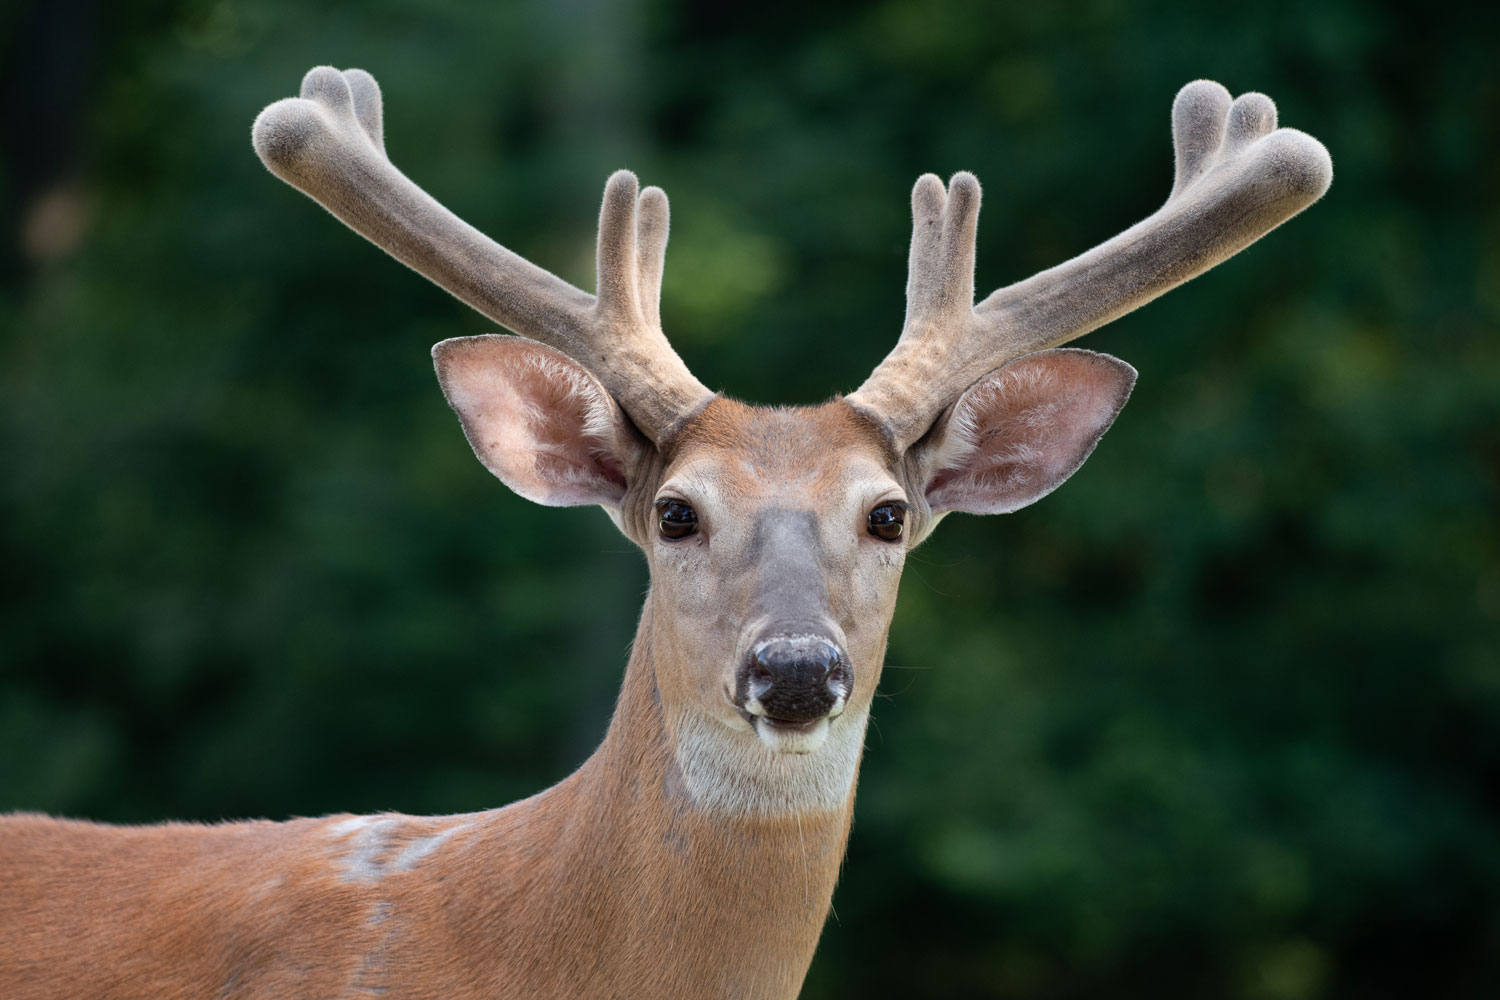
[0,604,854,1000]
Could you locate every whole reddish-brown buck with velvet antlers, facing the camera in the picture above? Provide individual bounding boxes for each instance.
[0,67,1332,1000]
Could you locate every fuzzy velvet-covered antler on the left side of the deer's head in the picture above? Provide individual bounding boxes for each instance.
[254,66,713,442]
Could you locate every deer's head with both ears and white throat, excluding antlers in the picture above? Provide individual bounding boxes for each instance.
[434,336,1136,811]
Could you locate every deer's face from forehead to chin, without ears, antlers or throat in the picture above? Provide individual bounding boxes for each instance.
[627,399,915,754]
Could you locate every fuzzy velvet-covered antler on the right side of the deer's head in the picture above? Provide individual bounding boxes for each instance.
[848,79,1334,448]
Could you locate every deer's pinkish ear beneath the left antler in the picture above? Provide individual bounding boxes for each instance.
[432,334,642,507]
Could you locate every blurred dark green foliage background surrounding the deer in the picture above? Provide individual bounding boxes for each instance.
[0,0,1500,1000]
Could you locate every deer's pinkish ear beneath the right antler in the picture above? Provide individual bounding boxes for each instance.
[921,348,1136,514]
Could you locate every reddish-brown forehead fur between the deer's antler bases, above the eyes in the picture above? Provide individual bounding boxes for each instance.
[669,397,896,477]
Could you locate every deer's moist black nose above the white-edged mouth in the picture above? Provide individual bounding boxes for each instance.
[740,636,849,723]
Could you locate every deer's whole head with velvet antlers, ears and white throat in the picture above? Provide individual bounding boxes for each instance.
[254,67,1332,813]
